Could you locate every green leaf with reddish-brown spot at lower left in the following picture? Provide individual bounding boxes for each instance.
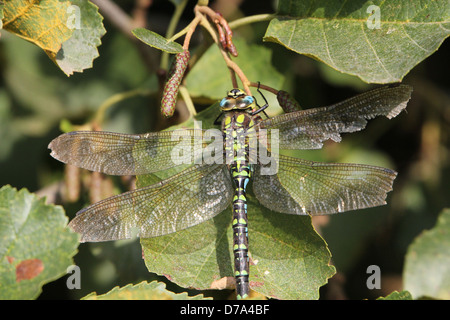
[0,186,78,299]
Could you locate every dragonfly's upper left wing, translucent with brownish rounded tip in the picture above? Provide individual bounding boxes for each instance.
[48,129,208,175]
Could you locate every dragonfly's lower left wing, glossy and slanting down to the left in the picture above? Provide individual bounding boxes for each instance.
[69,165,234,242]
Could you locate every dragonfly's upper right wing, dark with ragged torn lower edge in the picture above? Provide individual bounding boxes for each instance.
[259,85,412,149]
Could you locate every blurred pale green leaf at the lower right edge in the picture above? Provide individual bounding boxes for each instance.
[403,209,450,300]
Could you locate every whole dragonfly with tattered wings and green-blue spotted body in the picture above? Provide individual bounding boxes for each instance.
[49,84,412,299]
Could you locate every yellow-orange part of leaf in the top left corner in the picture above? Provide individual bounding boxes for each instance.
[3,0,73,58]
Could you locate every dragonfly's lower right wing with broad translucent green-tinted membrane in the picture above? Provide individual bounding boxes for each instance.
[253,155,397,215]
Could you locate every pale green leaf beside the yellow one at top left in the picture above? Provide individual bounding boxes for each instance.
[56,0,106,75]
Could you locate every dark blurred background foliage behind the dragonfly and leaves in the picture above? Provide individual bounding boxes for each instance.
[0,0,450,299]
